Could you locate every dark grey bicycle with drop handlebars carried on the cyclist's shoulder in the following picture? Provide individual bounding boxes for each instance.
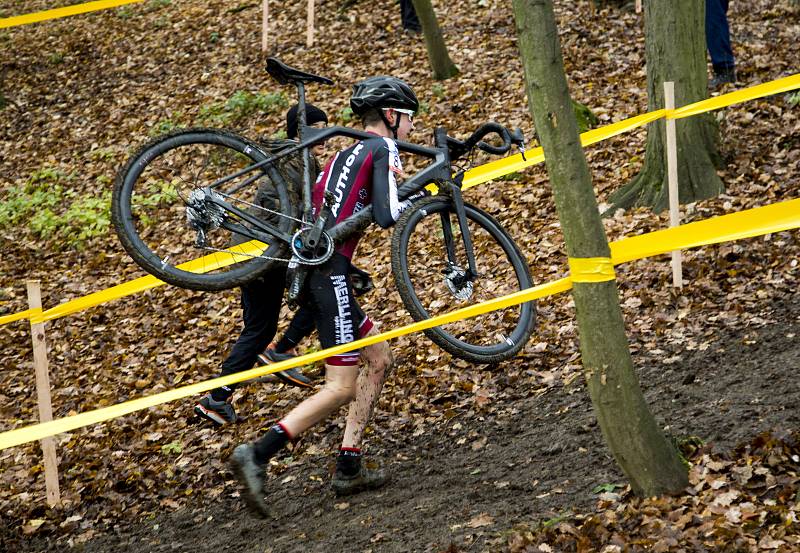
[112,58,536,363]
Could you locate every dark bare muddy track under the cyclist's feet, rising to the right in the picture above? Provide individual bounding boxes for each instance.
[18,295,800,553]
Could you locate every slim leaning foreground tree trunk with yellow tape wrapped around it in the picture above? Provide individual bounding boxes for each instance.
[513,0,688,496]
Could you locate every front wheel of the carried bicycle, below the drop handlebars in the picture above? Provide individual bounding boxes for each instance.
[392,197,536,363]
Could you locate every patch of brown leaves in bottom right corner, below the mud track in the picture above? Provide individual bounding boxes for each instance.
[508,433,800,552]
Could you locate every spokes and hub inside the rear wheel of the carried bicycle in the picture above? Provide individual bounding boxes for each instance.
[117,133,287,284]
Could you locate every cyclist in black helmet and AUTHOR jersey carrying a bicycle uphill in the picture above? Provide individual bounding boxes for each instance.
[231,76,421,514]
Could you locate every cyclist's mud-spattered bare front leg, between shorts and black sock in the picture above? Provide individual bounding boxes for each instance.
[342,328,394,448]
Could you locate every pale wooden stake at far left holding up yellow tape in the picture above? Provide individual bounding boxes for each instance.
[27,280,61,507]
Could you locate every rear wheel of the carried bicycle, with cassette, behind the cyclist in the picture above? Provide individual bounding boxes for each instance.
[112,129,294,290]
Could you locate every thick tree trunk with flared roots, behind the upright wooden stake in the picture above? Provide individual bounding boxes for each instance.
[610,0,725,212]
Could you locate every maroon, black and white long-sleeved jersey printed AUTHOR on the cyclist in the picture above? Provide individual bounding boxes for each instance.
[312,135,408,259]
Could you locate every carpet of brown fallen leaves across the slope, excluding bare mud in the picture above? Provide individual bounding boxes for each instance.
[0,0,800,551]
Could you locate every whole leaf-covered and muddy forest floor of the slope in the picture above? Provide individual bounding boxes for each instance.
[0,0,800,553]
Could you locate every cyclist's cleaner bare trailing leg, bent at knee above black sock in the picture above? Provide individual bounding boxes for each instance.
[281,365,358,438]
